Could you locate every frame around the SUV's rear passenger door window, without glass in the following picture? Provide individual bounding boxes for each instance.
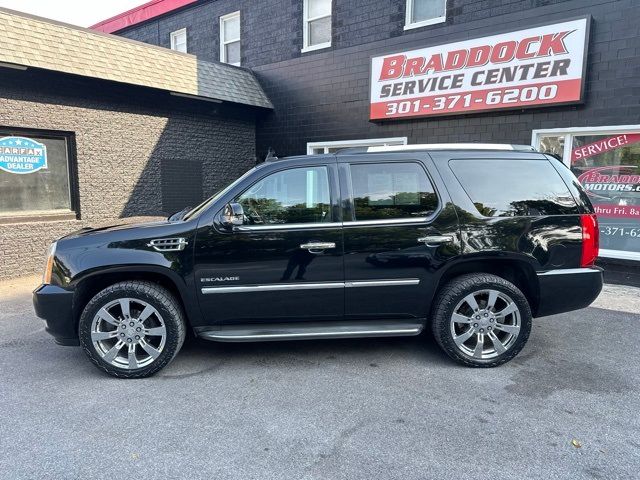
[341,158,444,227]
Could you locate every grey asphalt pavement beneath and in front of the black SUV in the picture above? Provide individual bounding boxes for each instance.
[0,278,640,480]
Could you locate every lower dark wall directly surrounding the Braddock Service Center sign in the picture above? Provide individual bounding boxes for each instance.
[254,0,640,156]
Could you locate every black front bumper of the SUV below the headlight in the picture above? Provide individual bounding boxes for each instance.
[33,285,80,345]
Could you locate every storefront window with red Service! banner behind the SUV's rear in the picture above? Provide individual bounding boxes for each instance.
[534,126,640,260]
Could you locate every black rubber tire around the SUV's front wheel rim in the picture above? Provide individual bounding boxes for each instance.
[78,282,185,378]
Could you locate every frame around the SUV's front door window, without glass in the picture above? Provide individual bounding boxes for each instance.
[230,162,342,232]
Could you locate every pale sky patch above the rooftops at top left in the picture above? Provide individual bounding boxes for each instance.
[0,0,149,27]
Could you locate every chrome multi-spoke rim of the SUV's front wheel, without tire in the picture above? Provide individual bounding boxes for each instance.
[91,298,167,370]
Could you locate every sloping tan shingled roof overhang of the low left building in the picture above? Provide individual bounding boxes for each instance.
[0,8,273,108]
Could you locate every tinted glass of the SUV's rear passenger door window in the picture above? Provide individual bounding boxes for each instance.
[351,162,438,220]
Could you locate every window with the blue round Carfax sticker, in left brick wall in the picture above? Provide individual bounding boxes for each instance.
[0,131,73,217]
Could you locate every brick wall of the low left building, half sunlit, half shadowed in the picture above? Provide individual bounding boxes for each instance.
[0,71,255,278]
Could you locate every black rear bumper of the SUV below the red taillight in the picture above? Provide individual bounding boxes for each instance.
[535,267,603,317]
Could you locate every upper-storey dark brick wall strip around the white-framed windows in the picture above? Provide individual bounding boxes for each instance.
[117,0,584,68]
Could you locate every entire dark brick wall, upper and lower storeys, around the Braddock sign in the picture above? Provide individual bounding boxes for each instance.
[115,0,640,156]
